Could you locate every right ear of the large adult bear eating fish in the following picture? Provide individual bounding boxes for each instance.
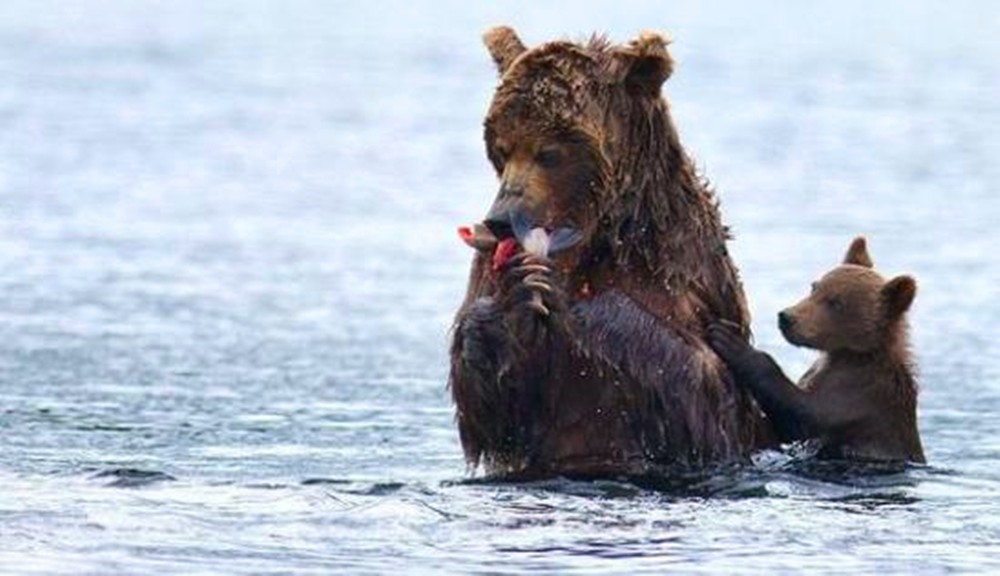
[608,32,674,98]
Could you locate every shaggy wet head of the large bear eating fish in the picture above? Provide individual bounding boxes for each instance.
[476,27,704,271]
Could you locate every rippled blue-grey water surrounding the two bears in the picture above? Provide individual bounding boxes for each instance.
[0,0,1000,574]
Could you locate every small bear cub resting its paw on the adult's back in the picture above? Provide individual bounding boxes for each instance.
[709,237,925,463]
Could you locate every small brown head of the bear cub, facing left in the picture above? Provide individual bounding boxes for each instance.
[778,237,917,353]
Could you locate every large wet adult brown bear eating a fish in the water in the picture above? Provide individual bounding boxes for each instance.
[450,27,774,477]
